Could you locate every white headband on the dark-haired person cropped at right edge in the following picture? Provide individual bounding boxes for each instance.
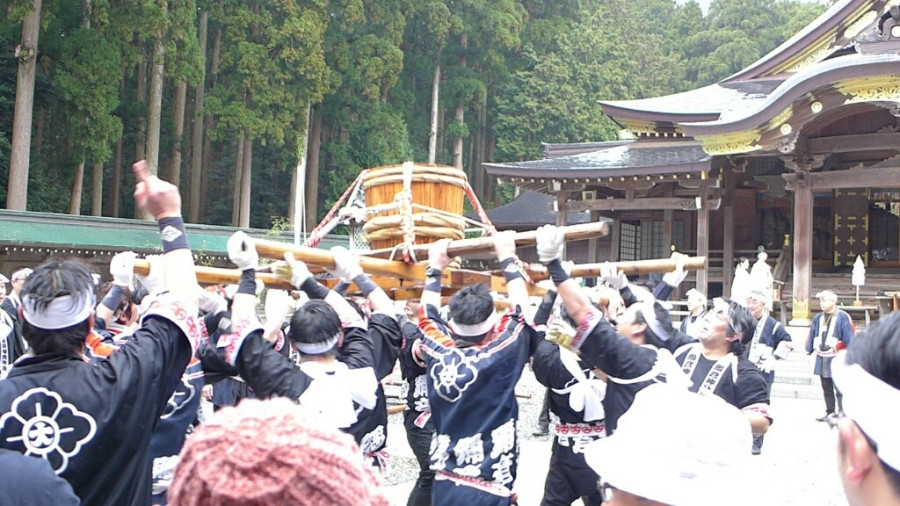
[832,352,900,471]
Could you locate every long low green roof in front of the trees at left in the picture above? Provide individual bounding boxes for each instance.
[0,211,347,255]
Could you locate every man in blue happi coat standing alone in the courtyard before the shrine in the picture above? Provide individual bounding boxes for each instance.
[806,290,856,422]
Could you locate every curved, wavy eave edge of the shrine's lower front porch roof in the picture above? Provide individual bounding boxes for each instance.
[680,54,900,137]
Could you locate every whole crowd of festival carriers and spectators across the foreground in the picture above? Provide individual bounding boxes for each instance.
[0,162,900,506]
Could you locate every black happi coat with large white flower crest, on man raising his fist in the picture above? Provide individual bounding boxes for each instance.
[0,300,201,506]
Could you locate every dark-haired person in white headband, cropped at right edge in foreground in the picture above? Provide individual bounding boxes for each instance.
[827,313,900,506]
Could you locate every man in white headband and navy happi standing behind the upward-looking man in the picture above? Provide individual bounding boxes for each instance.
[743,290,793,455]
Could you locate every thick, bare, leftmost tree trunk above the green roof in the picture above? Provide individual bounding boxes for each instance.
[6,0,41,211]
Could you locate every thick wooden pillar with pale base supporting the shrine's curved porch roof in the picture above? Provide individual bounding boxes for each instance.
[790,171,813,327]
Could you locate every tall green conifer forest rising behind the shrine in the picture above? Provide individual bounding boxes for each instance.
[0,0,827,228]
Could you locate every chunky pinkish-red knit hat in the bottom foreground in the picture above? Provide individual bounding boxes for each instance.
[168,399,389,506]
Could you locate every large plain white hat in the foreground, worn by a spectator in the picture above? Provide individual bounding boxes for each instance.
[585,384,752,506]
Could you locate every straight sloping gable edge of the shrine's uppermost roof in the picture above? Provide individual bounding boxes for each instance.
[720,0,888,83]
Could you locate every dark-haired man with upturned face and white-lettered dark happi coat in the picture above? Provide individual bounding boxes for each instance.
[675,298,772,434]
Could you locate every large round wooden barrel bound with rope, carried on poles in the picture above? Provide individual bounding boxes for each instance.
[362,162,466,250]
